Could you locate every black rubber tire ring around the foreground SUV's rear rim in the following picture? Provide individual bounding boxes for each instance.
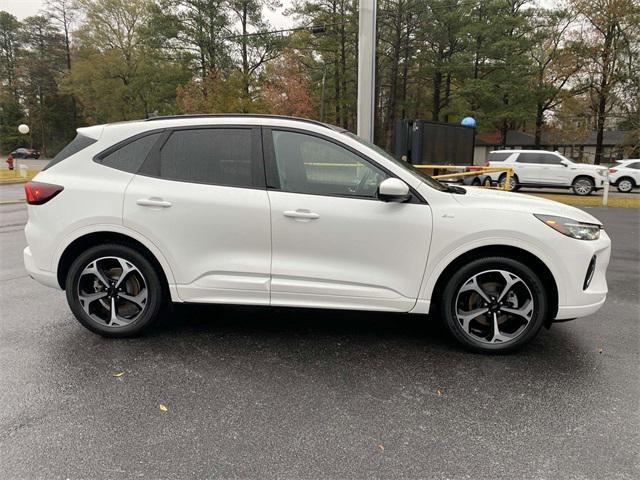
[65,244,163,338]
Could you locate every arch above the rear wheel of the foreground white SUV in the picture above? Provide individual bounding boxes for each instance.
[56,230,175,301]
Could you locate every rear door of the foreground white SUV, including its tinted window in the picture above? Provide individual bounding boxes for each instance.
[124,126,271,305]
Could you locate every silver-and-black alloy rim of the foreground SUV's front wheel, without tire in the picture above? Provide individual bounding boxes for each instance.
[455,270,535,344]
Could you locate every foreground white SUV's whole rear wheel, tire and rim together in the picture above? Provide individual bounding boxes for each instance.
[65,244,163,338]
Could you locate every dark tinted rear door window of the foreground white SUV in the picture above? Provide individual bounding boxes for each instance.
[159,128,255,187]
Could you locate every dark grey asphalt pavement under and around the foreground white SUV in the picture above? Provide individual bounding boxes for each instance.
[0,204,640,479]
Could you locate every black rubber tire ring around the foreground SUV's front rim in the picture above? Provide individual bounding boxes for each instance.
[440,257,549,354]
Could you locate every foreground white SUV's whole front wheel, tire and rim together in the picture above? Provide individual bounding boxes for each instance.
[439,257,549,354]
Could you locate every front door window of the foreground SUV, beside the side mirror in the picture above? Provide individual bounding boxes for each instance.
[272,130,388,198]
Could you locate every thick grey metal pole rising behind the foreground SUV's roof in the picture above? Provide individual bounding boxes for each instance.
[358,0,376,142]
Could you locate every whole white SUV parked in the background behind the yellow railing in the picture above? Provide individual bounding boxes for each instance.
[487,150,607,195]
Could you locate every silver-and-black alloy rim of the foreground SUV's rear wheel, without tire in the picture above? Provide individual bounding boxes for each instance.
[77,257,148,328]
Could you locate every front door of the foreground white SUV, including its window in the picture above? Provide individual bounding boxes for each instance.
[263,129,432,311]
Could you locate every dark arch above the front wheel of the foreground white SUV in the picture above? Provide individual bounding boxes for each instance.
[429,248,559,326]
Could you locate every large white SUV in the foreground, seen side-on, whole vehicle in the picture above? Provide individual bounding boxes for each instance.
[24,115,610,352]
